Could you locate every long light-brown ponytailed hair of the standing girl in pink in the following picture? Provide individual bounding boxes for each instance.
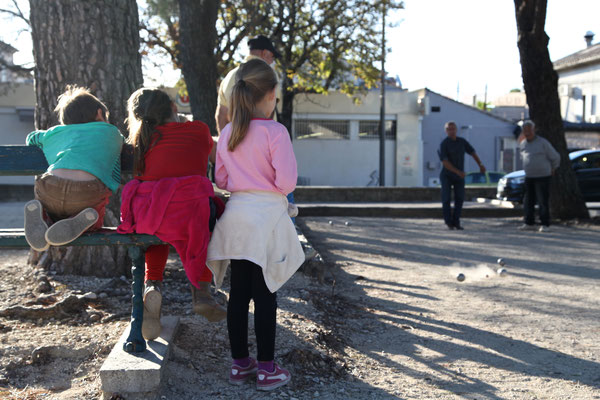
[227,59,277,151]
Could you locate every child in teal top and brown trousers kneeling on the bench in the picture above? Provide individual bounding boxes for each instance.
[25,86,124,251]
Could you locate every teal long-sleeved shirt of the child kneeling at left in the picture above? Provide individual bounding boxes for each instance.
[25,122,125,193]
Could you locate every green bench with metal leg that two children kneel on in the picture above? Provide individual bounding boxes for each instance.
[0,146,163,353]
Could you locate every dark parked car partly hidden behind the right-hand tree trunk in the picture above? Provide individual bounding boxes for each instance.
[496,149,600,203]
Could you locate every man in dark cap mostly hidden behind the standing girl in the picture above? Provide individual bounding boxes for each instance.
[215,35,281,133]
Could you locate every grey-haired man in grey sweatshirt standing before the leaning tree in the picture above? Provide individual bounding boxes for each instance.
[519,121,560,232]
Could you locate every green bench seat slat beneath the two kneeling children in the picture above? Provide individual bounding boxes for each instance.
[0,228,164,248]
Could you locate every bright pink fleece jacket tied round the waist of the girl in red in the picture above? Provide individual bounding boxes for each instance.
[117,175,222,286]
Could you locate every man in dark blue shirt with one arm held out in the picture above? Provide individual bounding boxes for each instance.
[439,121,485,230]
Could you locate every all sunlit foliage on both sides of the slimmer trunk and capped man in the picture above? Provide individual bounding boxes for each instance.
[141,0,402,94]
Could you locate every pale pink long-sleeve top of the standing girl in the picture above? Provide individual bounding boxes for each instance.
[215,118,298,195]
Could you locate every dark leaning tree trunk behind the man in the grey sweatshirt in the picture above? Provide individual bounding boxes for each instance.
[515,0,589,219]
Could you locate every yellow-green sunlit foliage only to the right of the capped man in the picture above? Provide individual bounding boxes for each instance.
[262,0,402,99]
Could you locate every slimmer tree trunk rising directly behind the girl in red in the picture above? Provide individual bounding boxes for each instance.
[178,0,219,136]
